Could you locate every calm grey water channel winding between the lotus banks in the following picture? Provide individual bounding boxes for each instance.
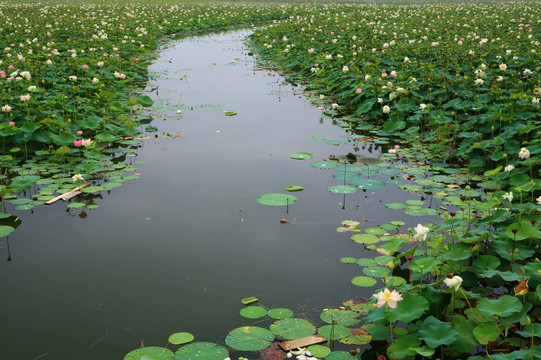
[0,31,422,360]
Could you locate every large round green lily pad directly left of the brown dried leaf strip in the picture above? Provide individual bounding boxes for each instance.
[225,326,274,352]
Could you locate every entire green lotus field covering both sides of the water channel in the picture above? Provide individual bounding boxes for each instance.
[0,2,541,360]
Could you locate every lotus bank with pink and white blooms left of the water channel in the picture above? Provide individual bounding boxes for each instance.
[0,2,294,236]
